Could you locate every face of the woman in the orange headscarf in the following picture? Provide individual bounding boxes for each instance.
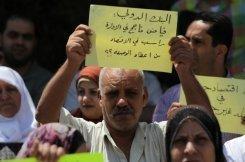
[77,78,102,119]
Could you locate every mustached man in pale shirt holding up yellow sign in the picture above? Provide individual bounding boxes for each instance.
[36,25,213,162]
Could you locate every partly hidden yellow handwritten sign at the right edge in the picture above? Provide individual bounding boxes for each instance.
[180,76,245,134]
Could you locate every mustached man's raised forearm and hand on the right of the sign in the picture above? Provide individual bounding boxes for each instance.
[169,36,213,114]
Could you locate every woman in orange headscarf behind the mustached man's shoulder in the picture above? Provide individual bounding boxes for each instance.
[72,66,103,123]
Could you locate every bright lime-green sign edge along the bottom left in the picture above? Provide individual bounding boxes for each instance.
[3,153,103,162]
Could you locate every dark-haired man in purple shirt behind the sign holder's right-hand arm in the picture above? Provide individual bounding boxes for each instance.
[153,12,233,122]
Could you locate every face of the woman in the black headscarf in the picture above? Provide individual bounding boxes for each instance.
[171,119,215,162]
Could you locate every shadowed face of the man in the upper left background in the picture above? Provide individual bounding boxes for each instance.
[2,19,36,67]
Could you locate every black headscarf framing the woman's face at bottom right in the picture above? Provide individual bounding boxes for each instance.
[165,105,225,162]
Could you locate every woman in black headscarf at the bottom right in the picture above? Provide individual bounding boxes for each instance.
[165,105,225,162]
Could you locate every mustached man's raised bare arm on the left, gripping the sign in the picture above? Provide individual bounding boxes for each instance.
[36,25,91,123]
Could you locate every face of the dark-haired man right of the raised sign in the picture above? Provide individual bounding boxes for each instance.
[186,20,216,75]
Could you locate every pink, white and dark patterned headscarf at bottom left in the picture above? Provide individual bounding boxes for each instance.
[18,123,85,157]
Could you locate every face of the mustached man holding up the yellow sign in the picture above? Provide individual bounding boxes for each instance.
[100,69,148,131]
